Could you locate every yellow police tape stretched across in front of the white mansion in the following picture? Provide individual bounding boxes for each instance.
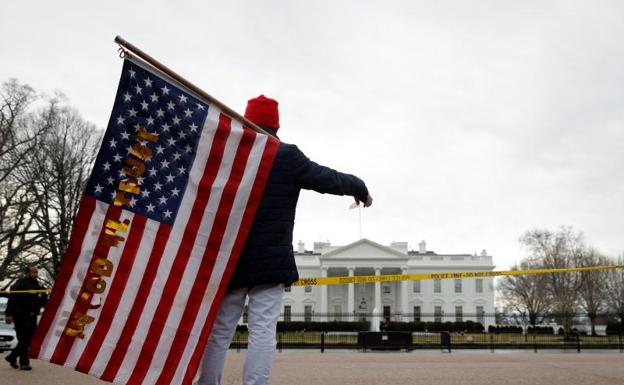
[292,265,624,286]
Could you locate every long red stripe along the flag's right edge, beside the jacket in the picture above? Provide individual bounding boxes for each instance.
[179,131,279,385]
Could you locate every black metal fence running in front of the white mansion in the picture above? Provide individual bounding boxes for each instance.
[231,313,624,352]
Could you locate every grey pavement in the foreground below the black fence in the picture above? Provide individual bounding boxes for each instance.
[0,351,624,385]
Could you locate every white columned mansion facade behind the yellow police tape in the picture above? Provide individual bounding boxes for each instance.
[281,239,495,328]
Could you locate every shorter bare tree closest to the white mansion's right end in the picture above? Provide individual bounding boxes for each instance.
[498,259,550,327]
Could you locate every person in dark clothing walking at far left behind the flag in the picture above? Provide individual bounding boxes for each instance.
[4,266,47,370]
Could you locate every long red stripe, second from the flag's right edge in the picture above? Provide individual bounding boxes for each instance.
[148,124,256,385]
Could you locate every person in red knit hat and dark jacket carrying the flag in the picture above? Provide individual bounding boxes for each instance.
[197,95,373,385]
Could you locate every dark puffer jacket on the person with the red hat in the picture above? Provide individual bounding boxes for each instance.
[229,131,368,289]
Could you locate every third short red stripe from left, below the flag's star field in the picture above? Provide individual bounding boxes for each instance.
[75,215,147,373]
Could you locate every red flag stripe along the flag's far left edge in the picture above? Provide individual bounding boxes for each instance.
[30,196,96,357]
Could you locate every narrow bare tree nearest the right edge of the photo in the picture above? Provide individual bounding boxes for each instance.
[578,248,609,336]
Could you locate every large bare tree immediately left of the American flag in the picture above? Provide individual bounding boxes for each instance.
[18,96,101,279]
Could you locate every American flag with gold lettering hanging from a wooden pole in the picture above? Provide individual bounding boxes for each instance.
[30,58,279,385]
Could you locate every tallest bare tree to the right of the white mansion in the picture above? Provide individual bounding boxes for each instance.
[520,227,584,335]
